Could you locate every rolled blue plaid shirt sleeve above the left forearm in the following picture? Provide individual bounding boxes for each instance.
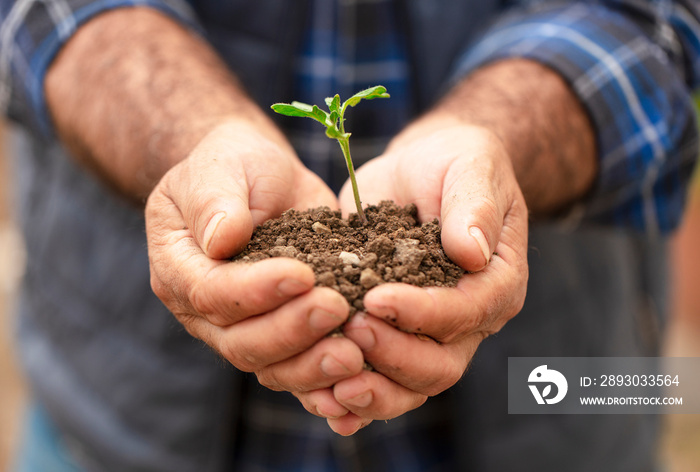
[0,0,197,136]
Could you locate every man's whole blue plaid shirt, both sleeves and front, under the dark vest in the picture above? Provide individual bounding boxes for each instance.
[0,0,700,471]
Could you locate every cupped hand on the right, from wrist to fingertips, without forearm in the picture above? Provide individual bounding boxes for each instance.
[292,116,528,434]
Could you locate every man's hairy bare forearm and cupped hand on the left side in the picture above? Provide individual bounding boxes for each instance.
[46,7,370,406]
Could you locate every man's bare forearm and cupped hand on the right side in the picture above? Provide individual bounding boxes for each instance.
[318,59,597,434]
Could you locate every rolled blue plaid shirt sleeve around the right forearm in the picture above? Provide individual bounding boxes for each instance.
[456,0,700,234]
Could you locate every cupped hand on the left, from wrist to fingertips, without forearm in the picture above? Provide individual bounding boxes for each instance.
[146,122,363,410]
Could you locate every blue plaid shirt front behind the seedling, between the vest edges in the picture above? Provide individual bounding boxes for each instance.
[283,0,411,195]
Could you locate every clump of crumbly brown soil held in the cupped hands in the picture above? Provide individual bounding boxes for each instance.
[234,201,464,316]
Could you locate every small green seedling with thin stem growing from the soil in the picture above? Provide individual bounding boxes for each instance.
[272,85,389,224]
